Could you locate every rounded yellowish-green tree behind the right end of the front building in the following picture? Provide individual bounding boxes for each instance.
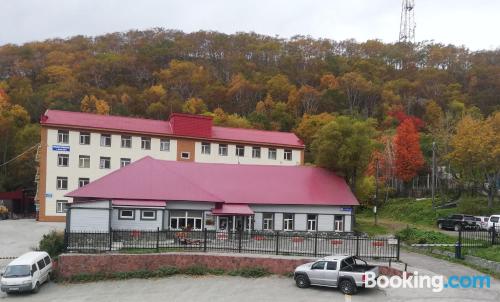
[312,116,377,191]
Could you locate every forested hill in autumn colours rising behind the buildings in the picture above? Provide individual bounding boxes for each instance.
[0,29,500,203]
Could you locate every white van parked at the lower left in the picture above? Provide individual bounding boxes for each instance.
[0,252,52,294]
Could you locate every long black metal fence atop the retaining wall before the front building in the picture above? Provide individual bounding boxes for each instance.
[65,229,400,260]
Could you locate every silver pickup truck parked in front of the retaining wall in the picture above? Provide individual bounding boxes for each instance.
[294,255,379,295]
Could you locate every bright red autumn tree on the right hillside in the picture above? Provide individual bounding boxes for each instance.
[394,119,424,182]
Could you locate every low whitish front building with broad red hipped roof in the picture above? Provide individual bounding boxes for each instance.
[66,156,358,232]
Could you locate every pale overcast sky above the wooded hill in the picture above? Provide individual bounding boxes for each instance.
[0,0,500,50]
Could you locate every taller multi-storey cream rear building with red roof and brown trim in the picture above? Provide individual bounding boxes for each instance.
[36,110,304,221]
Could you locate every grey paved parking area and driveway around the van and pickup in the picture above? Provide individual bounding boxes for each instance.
[0,220,500,302]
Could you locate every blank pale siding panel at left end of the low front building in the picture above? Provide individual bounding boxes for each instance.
[69,208,109,232]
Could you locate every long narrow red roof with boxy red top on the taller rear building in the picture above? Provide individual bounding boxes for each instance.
[40,110,304,148]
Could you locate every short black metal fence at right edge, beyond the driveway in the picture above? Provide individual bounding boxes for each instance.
[455,224,500,258]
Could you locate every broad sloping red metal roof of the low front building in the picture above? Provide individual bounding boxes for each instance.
[66,156,358,205]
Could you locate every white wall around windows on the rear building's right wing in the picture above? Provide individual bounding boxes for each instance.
[195,142,302,166]
